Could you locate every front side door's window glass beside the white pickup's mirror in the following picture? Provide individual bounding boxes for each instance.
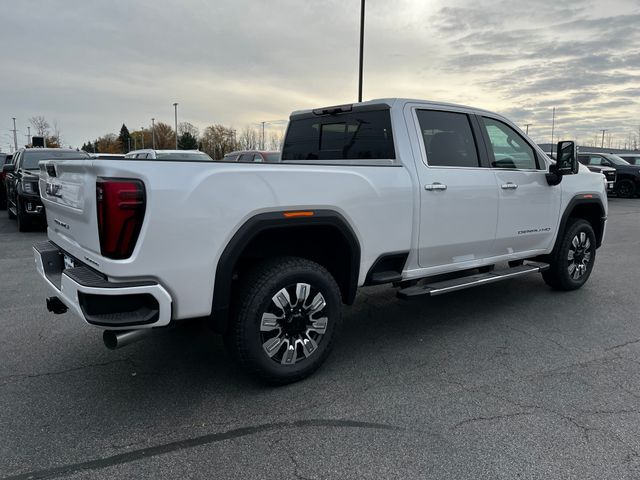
[482,117,538,170]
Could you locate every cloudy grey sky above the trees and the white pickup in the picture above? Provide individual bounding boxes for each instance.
[0,0,640,150]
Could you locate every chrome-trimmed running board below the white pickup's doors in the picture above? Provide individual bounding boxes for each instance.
[398,262,549,299]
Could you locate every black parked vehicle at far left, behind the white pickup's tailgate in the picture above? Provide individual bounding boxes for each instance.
[2,148,91,232]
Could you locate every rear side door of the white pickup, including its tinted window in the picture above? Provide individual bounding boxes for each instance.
[411,107,498,271]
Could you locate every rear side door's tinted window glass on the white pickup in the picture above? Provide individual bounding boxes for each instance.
[417,110,480,168]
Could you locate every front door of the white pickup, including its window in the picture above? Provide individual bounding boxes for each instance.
[478,116,561,255]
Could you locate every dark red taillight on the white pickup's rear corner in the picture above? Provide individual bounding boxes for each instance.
[96,178,146,259]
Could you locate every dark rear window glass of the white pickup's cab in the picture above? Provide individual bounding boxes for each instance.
[282,110,396,161]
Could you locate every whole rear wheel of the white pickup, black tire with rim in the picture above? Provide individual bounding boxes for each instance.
[225,257,342,385]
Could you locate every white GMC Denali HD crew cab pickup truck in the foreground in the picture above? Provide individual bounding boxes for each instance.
[34,99,607,383]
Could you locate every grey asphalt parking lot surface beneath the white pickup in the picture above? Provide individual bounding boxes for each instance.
[0,199,640,479]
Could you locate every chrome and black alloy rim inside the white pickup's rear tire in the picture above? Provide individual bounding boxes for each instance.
[260,283,329,365]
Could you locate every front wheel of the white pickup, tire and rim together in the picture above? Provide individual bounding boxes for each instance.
[542,218,596,290]
